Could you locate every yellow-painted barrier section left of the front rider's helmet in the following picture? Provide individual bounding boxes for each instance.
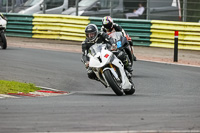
[33,14,90,41]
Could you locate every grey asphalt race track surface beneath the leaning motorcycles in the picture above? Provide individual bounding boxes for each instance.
[0,47,200,133]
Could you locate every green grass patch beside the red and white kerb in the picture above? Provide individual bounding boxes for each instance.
[0,80,40,94]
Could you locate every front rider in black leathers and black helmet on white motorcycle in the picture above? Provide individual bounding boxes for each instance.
[81,24,133,80]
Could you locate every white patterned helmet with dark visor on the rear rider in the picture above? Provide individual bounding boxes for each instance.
[102,16,113,32]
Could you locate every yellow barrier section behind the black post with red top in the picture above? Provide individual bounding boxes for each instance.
[150,20,200,50]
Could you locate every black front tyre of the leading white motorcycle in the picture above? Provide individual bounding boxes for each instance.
[104,70,124,96]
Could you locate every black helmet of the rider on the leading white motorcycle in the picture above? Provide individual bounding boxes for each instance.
[85,24,98,41]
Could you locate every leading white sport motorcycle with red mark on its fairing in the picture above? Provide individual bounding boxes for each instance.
[88,43,135,96]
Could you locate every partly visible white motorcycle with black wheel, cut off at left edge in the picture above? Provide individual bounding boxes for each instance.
[0,16,7,49]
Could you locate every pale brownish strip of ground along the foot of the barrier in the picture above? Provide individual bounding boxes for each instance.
[7,37,200,67]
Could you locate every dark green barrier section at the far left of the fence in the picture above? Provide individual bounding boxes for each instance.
[4,13,33,37]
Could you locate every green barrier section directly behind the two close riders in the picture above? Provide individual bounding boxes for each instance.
[90,17,151,46]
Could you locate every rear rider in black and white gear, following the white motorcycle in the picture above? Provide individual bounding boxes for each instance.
[101,16,136,61]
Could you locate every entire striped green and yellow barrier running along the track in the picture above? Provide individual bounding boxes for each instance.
[4,13,200,50]
